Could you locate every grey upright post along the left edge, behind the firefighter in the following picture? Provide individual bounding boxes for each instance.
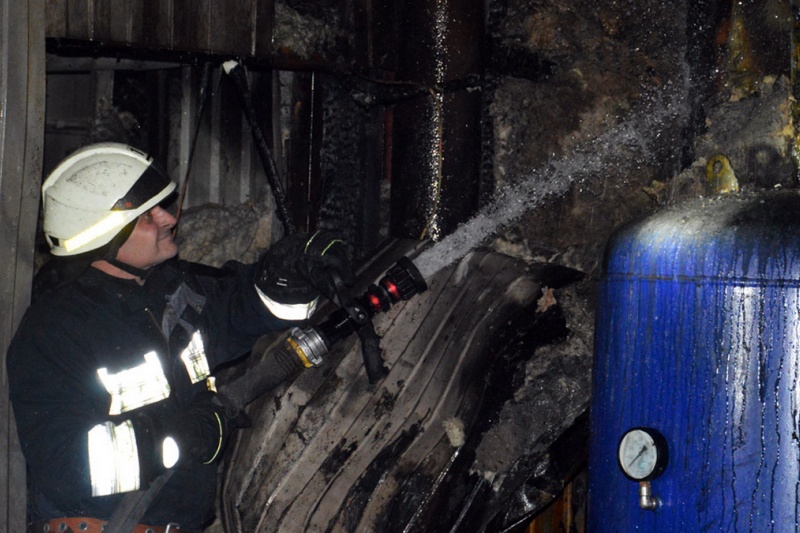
[0,0,45,533]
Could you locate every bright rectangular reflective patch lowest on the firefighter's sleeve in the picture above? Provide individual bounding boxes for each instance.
[88,420,141,496]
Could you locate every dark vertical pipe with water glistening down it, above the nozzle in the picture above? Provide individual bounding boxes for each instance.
[391,0,484,240]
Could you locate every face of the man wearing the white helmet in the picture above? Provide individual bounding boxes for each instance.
[117,206,178,269]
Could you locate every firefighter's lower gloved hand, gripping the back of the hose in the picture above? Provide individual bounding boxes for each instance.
[163,391,249,464]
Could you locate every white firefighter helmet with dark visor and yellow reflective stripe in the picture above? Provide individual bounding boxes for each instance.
[42,143,175,255]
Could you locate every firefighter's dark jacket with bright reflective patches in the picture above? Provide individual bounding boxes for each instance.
[7,260,291,529]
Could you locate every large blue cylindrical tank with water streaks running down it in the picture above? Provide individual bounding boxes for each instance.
[587,191,800,533]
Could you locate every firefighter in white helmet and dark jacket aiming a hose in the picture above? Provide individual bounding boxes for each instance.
[7,143,352,532]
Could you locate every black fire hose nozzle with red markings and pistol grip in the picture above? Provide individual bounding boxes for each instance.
[220,257,428,408]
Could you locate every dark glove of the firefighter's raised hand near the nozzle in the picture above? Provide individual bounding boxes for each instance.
[256,230,355,305]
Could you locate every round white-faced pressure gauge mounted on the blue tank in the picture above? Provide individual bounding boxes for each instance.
[617,427,669,481]
